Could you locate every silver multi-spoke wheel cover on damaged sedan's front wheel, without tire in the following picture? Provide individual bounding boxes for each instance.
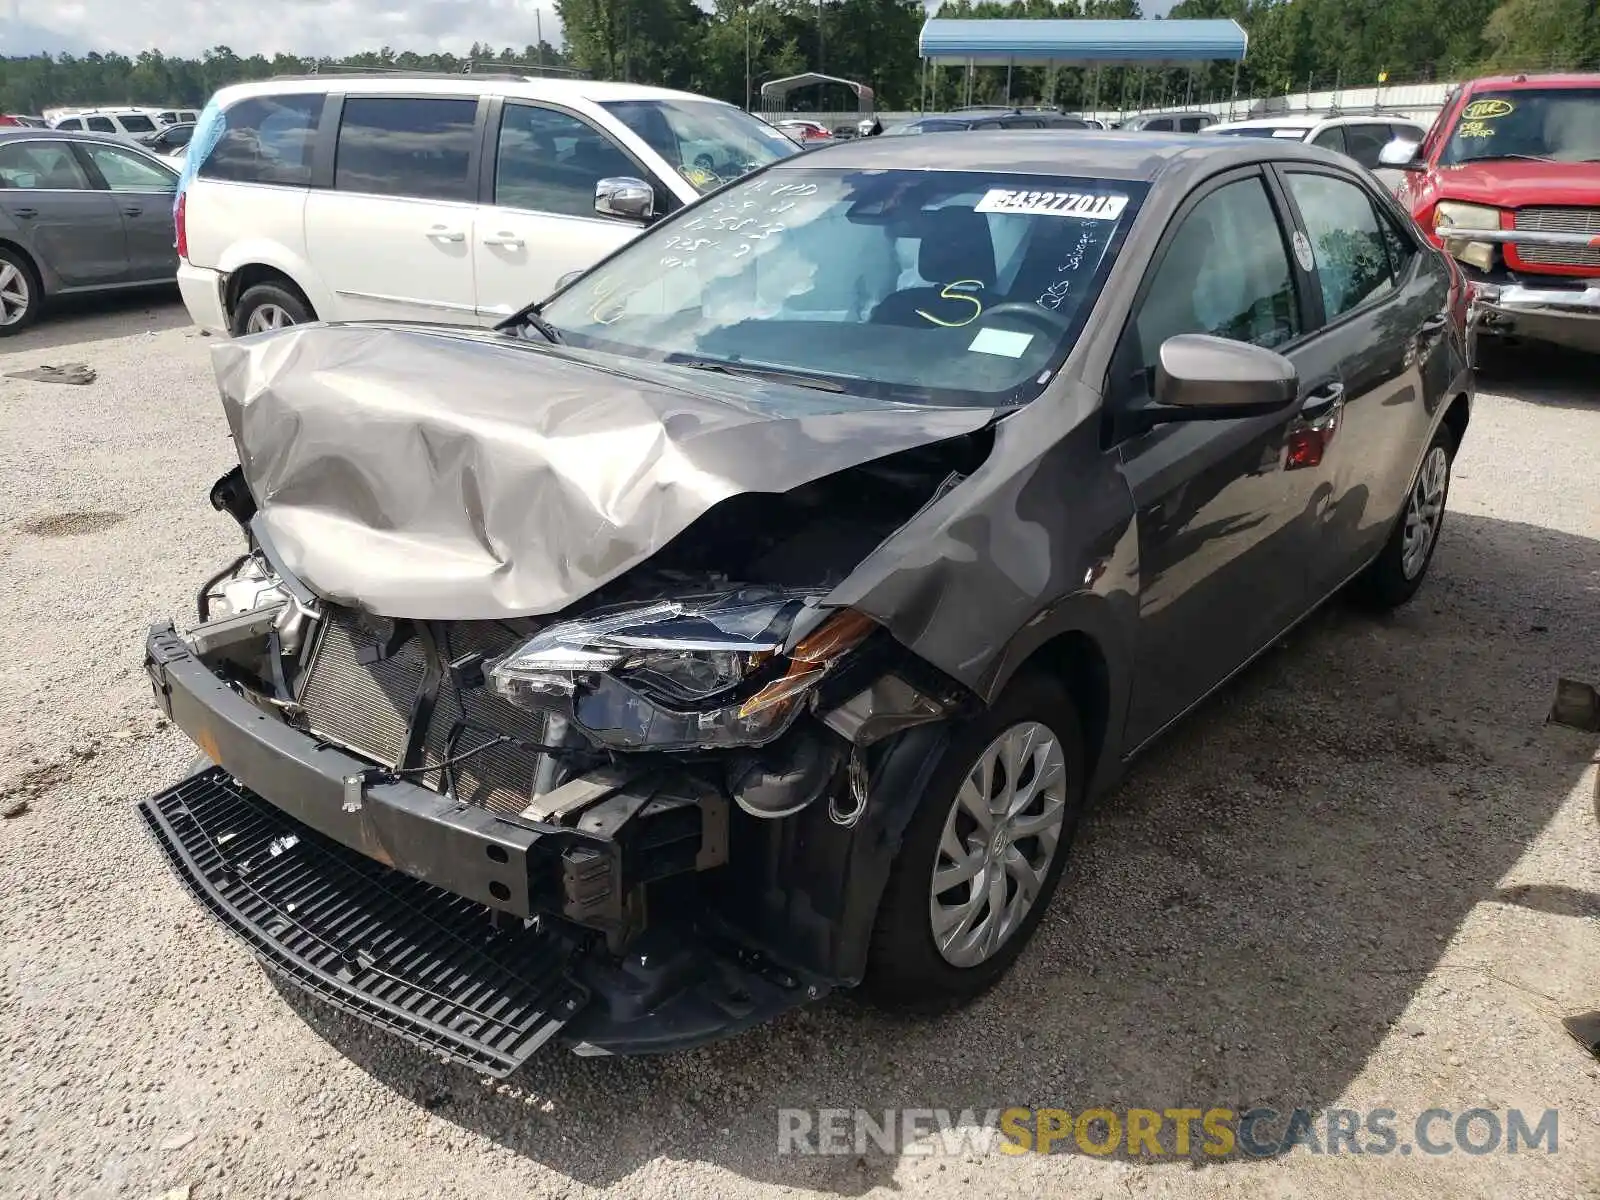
[928,722,1067,968]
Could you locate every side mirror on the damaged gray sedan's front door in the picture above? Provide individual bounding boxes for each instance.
[1147,333,1299,424]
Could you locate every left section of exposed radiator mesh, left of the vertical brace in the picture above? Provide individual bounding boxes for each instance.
[299,608,427,766]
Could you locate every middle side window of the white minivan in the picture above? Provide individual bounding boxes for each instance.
[333,96,478,200]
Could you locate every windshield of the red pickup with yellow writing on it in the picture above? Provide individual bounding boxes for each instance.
[1438,88,1600,163]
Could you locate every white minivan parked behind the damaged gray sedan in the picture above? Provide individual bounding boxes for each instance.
[176,75,798,334]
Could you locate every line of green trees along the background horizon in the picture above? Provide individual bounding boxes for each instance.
[0,0,1600,112]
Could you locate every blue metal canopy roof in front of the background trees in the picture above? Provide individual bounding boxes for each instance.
[917,19,1250,67]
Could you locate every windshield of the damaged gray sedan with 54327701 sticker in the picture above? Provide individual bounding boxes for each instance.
[541,168,1146,406]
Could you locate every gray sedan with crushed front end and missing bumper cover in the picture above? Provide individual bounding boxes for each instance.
[141,133,1472,1075]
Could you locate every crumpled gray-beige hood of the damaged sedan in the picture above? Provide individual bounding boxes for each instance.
[213,325,994,621]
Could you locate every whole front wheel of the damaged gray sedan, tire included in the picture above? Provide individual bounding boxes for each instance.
[862,672,1085,1013]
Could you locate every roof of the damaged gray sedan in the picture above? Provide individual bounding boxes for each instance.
[768,130,1346,182]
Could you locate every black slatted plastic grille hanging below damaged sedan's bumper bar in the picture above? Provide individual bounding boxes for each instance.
[139,768,587,1077]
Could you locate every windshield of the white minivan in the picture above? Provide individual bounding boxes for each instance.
[602,99,800,195]
